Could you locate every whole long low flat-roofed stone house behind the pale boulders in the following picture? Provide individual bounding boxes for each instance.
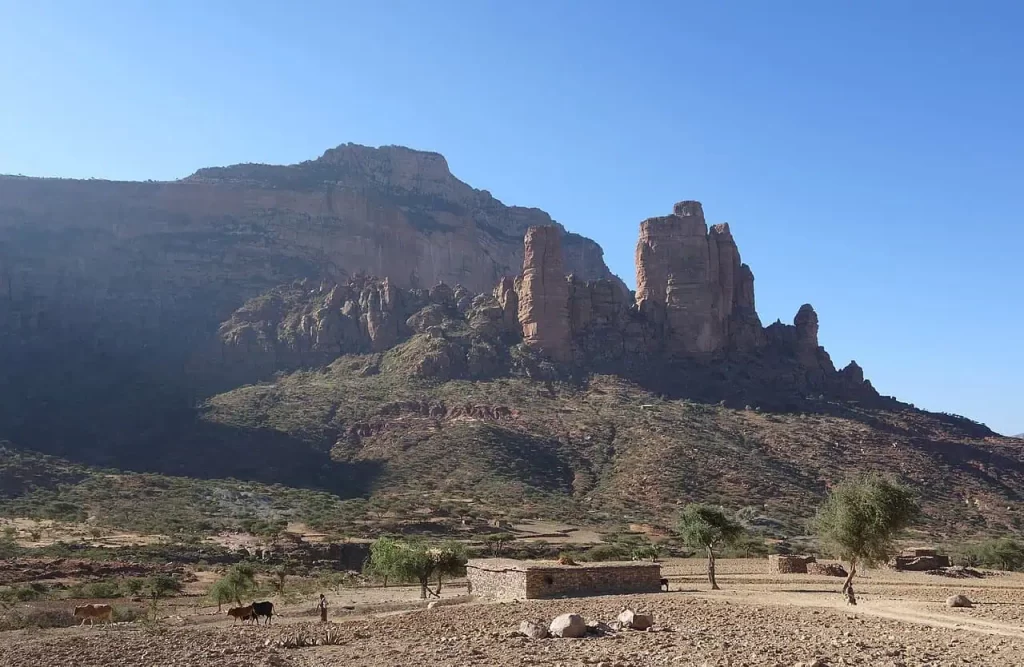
[466,558,662,599]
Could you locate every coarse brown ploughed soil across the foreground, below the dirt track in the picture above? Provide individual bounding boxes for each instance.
[0,593,1024,667]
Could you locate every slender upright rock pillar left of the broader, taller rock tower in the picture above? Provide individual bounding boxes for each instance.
[516,225,572,362]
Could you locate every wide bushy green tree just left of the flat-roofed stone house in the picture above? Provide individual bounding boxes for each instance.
[366,537,466,598]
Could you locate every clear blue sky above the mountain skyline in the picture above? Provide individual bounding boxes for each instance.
[0,0,1024,432]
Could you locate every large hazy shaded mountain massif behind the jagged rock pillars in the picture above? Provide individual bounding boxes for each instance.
[0,144,625,459]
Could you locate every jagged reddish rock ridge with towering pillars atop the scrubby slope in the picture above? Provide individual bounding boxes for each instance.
[221,202,880,403]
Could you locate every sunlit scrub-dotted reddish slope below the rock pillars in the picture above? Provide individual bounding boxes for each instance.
[195,340,1024,537]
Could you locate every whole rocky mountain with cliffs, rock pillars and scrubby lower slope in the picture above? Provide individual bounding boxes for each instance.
[0,144,1024,533]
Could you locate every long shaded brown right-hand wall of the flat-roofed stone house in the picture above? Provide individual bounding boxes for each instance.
[526,562,662,598]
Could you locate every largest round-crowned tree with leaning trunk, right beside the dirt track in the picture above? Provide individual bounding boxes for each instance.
[815,474,919,605]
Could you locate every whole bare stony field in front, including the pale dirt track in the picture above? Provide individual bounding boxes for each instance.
[0,560,1024,667]
